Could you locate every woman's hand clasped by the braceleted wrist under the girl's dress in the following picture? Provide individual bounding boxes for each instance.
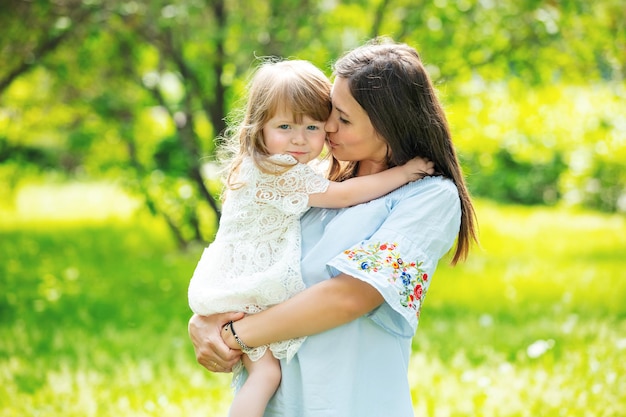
[188,313,244,372]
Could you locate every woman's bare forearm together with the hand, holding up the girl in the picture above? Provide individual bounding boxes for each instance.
[189,274,383,372]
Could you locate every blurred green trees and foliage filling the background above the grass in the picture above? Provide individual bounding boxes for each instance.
[0,0,626,246]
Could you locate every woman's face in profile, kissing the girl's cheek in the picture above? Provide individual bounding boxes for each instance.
[324,77,387,174]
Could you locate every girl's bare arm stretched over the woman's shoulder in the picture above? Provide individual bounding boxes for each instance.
[309,157,435,208]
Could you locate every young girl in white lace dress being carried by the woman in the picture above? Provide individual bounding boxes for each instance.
[189,60,433,417]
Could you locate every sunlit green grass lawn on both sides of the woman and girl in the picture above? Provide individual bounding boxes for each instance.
[0,186,626,417]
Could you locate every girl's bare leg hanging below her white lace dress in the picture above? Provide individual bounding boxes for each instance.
[228,349,281,417]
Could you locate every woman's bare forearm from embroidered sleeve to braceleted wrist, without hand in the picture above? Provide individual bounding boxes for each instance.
[221,274,384,350]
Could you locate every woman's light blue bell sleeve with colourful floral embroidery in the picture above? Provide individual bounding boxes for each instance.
[327,177,461,338]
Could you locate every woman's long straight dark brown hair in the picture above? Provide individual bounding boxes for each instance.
[330,38,478,264]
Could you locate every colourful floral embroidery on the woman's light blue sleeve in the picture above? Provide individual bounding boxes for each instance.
[344,243,428,317]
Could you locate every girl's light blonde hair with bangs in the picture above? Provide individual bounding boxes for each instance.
[222,59,331,188]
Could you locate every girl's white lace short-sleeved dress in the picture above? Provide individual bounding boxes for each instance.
[188,155,329,360]
